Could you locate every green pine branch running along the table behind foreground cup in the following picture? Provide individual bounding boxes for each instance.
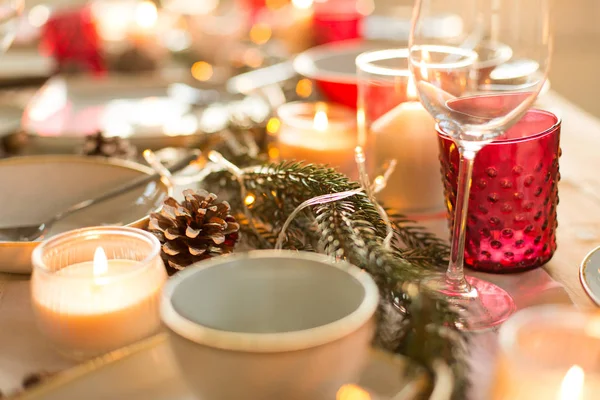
[204,162,468,398]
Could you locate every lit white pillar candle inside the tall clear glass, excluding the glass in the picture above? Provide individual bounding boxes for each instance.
[371,79,443,213]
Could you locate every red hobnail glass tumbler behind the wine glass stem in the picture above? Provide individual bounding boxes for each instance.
[438,110,561,273]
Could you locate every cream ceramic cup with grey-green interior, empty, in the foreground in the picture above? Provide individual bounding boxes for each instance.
[161,250,378,400]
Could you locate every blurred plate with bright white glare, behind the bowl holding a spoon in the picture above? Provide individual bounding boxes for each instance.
[22,74,234,153]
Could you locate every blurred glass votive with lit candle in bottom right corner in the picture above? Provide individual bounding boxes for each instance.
[489,305,600,400]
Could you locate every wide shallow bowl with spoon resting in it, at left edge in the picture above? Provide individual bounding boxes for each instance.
[0,155,172,273]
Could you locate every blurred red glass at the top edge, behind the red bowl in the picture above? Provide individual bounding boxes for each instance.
[313,0,365,44]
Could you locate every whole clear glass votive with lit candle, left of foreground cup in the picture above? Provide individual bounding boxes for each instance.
[31,227,167,360]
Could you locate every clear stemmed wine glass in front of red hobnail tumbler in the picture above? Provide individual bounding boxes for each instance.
[409,0,552,330]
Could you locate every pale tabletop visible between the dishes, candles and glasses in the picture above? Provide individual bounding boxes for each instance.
[0,88,600,399]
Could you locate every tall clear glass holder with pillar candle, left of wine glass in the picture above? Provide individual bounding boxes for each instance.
[356,49,444,215]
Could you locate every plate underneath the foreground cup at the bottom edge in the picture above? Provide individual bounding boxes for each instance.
[17,334,425,400]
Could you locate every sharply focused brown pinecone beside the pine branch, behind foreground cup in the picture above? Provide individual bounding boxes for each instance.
[148,189,240,274]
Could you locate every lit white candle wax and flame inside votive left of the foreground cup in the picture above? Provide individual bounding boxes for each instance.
[32,247,166,358]
